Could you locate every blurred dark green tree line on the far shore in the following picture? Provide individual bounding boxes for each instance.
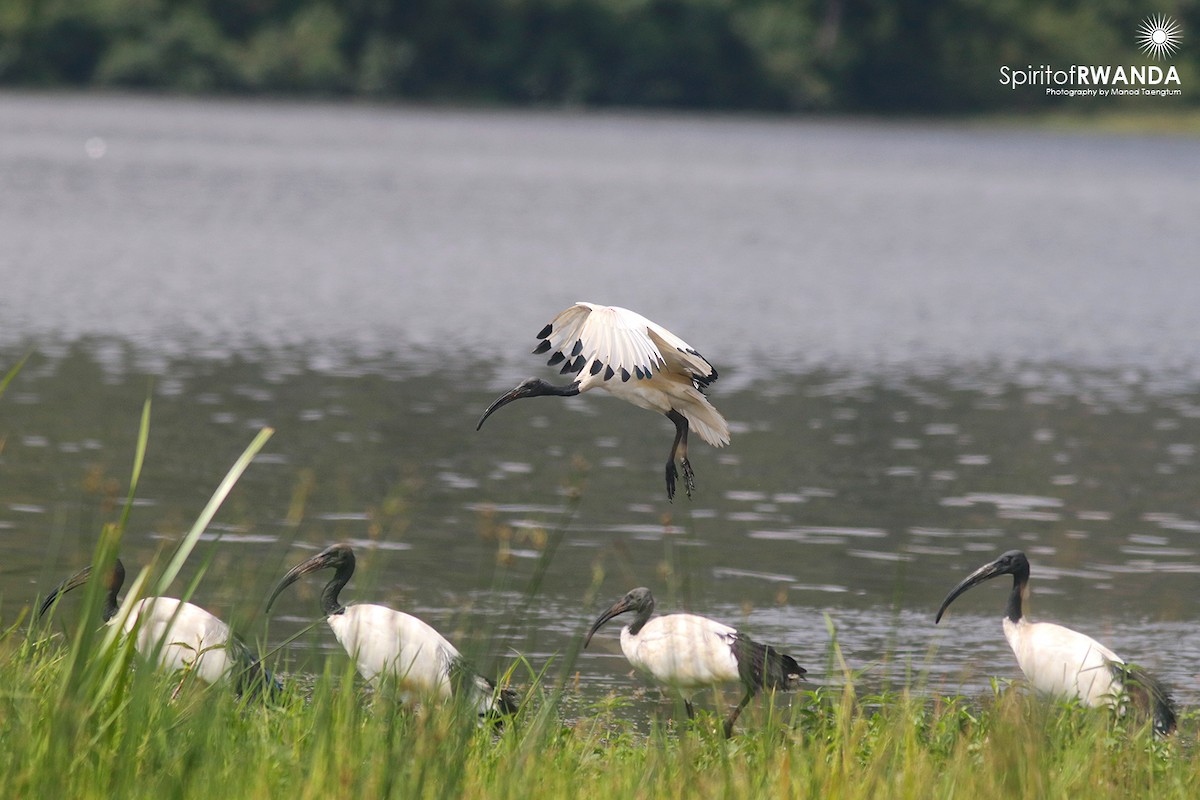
[0,0,1200,113]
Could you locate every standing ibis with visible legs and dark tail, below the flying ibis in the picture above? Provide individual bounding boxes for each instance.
[583,587,808,738]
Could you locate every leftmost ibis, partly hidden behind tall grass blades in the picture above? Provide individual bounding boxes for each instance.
[37,559,281,692]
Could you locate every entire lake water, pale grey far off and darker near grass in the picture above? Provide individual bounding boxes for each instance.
[0,95,1200,703]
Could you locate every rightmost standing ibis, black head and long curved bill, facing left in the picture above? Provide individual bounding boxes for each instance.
[935,551,1175,735]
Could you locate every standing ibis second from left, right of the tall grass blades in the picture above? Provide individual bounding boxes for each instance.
[266,545,517,716]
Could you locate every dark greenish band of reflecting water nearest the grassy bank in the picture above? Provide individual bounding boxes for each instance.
[0,343,1200,699]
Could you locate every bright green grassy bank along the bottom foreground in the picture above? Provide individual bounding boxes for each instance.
[0,625,1200,799]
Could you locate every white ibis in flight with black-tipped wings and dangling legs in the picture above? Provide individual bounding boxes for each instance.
[475,302,730,500]
